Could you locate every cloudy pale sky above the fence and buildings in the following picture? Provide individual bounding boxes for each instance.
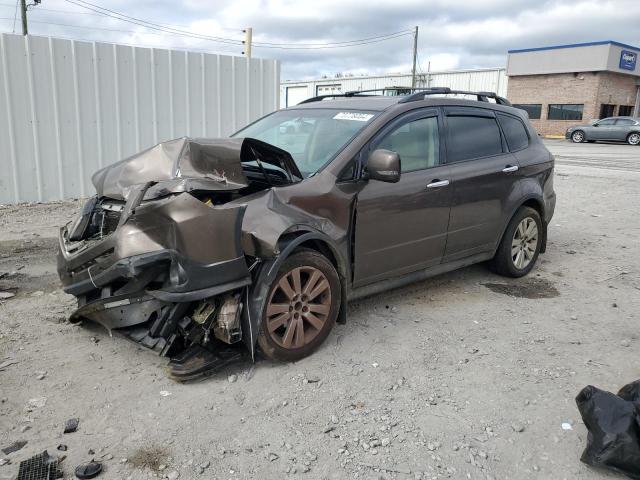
[0,0,640,80]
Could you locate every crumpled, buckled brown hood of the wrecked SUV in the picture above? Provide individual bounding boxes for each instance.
[91,137,302,200]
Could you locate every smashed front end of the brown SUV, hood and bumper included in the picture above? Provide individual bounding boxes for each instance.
[58,138,299,374]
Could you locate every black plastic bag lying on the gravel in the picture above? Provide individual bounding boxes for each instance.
[576,381,640,480]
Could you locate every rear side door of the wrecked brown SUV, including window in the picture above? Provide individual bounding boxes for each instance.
[443,107,528,262]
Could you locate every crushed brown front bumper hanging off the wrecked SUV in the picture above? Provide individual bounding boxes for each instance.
[58,193,250,338]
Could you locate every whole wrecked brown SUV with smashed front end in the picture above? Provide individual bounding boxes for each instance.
[58,89,555,377]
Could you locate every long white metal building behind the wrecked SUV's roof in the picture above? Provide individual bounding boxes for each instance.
[280,68,507,108]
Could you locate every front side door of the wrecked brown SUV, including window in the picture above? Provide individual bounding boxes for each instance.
[354,109,451,286]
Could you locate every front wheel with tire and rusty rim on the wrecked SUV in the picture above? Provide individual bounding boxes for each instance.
[258,249,341,362]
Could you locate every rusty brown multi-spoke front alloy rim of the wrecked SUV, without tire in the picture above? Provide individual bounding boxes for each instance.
[264,266,331,349]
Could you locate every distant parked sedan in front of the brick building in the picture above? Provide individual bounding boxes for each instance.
[564,117,640,145]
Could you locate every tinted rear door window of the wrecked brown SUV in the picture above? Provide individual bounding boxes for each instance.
[447,115,502,162]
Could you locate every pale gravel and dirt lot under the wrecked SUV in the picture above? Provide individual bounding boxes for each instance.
[0,141,640,479]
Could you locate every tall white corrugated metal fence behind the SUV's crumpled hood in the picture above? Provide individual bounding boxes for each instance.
[0,34,280,204]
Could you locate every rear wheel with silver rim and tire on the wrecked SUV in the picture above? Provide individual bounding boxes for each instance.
[489,207,543,278]
